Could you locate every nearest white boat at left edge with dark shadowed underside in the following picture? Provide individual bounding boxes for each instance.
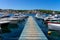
[0,20,10,33]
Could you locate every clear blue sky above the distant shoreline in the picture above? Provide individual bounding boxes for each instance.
[0,0,60,11]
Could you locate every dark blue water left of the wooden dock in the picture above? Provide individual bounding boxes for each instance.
[1,19,27,40]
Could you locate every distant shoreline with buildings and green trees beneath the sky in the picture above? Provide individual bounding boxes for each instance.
[0,9,60,14]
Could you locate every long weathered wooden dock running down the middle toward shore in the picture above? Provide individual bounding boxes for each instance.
[18,16,48,40]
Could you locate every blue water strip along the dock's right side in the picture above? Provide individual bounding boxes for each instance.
[34,18,51,40]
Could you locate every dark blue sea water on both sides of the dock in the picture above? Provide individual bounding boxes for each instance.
[0,14,60,40]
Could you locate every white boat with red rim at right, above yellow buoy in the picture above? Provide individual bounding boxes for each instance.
[47,20,60,30]
